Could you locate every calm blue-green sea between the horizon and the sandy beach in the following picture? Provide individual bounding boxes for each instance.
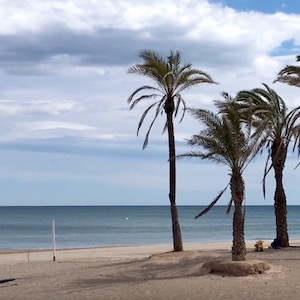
[0,206,300,250]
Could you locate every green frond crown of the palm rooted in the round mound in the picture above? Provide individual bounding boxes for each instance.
[183,93,263,170]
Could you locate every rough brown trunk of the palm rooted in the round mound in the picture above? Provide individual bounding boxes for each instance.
[230,171,246,261]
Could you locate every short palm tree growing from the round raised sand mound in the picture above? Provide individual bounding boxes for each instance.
[177,93,261,261]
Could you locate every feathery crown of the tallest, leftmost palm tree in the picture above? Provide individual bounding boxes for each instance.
[128,50,215,149]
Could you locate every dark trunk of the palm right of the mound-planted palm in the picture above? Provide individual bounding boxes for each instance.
[272,143,289,247]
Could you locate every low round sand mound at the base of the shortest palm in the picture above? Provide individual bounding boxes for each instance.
[202,260,271,276]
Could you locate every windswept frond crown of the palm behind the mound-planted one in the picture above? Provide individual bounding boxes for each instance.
[237,84,300,195]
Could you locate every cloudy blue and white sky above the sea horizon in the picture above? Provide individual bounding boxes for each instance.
[0,0,300,206]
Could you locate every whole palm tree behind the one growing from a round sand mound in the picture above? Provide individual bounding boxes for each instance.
[237,84,300,247]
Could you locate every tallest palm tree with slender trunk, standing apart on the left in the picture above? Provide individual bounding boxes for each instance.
[128,50,215,251]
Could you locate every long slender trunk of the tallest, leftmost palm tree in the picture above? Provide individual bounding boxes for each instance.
[166,110,183,251]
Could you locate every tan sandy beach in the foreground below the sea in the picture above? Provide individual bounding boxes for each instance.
[0,240,300,300]
